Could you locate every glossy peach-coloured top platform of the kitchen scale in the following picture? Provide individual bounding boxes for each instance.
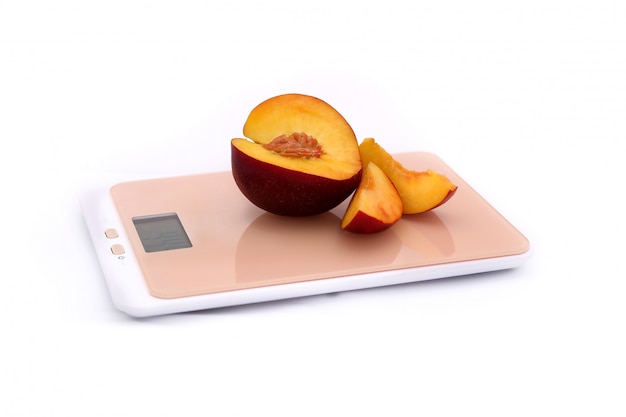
[107,153,529,300]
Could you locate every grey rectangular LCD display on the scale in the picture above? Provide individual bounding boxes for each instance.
[133,213,192,253]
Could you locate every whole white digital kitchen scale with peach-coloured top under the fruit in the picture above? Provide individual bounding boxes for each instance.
[82,152,530,317]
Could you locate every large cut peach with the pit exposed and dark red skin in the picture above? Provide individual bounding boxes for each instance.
[231,94,362,216]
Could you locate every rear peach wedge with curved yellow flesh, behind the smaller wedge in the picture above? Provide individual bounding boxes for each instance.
[359,138,457,214]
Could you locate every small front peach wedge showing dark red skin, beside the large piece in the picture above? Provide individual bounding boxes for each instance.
[341,162,402,233]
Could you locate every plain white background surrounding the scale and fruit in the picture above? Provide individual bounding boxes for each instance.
[0,0,626,417]
